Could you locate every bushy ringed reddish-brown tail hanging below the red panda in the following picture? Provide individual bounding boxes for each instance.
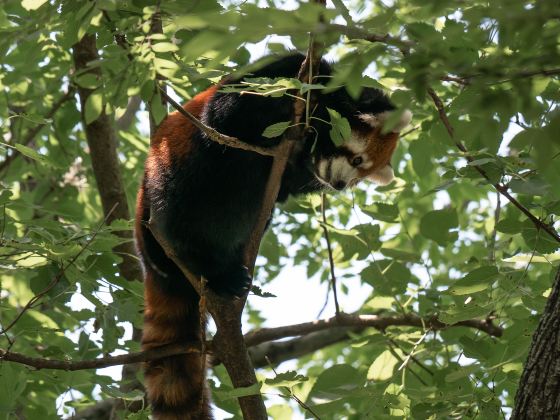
[136,191,212,420]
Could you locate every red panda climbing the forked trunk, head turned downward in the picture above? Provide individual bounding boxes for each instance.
[135,54,411,420]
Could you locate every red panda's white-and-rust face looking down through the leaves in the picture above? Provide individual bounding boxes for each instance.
[315,110,412,190]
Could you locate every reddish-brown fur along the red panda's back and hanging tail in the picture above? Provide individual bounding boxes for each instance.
[135,86,218,420]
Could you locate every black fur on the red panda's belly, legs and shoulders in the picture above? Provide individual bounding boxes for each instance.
[145,55,393,296]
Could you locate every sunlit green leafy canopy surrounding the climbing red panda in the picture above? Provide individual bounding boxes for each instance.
[0,0,560,419]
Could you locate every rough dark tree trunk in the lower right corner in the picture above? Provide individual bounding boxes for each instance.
[511,268,560,420]
